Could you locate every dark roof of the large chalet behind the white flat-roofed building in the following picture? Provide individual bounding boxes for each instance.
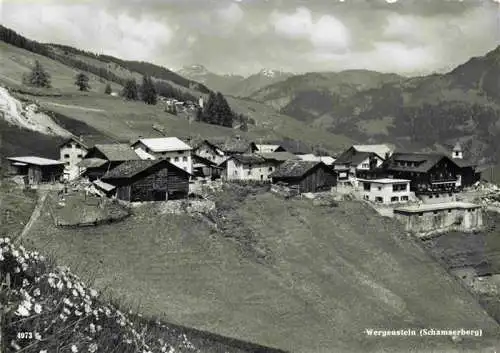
[384,152,458,173]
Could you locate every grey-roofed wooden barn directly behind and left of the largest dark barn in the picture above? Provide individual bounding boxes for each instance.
[78,143,141,181]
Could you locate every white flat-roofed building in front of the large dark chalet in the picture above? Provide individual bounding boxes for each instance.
[358,178,411,204]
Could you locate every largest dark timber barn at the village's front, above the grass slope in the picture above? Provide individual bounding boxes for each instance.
[102,159,191,202]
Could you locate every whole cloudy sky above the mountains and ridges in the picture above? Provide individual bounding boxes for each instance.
[0,0,500,75]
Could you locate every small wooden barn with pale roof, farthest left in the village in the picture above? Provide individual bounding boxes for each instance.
[7,156,64,185]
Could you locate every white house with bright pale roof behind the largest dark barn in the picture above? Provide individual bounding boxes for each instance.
[132,137,193,174]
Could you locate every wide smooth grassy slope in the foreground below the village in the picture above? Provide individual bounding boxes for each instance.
[27,189,499,353]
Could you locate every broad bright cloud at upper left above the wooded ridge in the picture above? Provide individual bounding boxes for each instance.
[3,2,174,60]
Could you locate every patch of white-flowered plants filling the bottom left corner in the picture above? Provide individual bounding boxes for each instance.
[0,238,199,353]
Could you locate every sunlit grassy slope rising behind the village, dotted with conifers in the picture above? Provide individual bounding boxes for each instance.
[0,33,351,152]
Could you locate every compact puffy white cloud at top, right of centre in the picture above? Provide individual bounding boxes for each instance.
[270,7,349,50]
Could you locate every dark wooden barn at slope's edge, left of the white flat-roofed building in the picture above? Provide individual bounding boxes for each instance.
[270,160,337,193]
